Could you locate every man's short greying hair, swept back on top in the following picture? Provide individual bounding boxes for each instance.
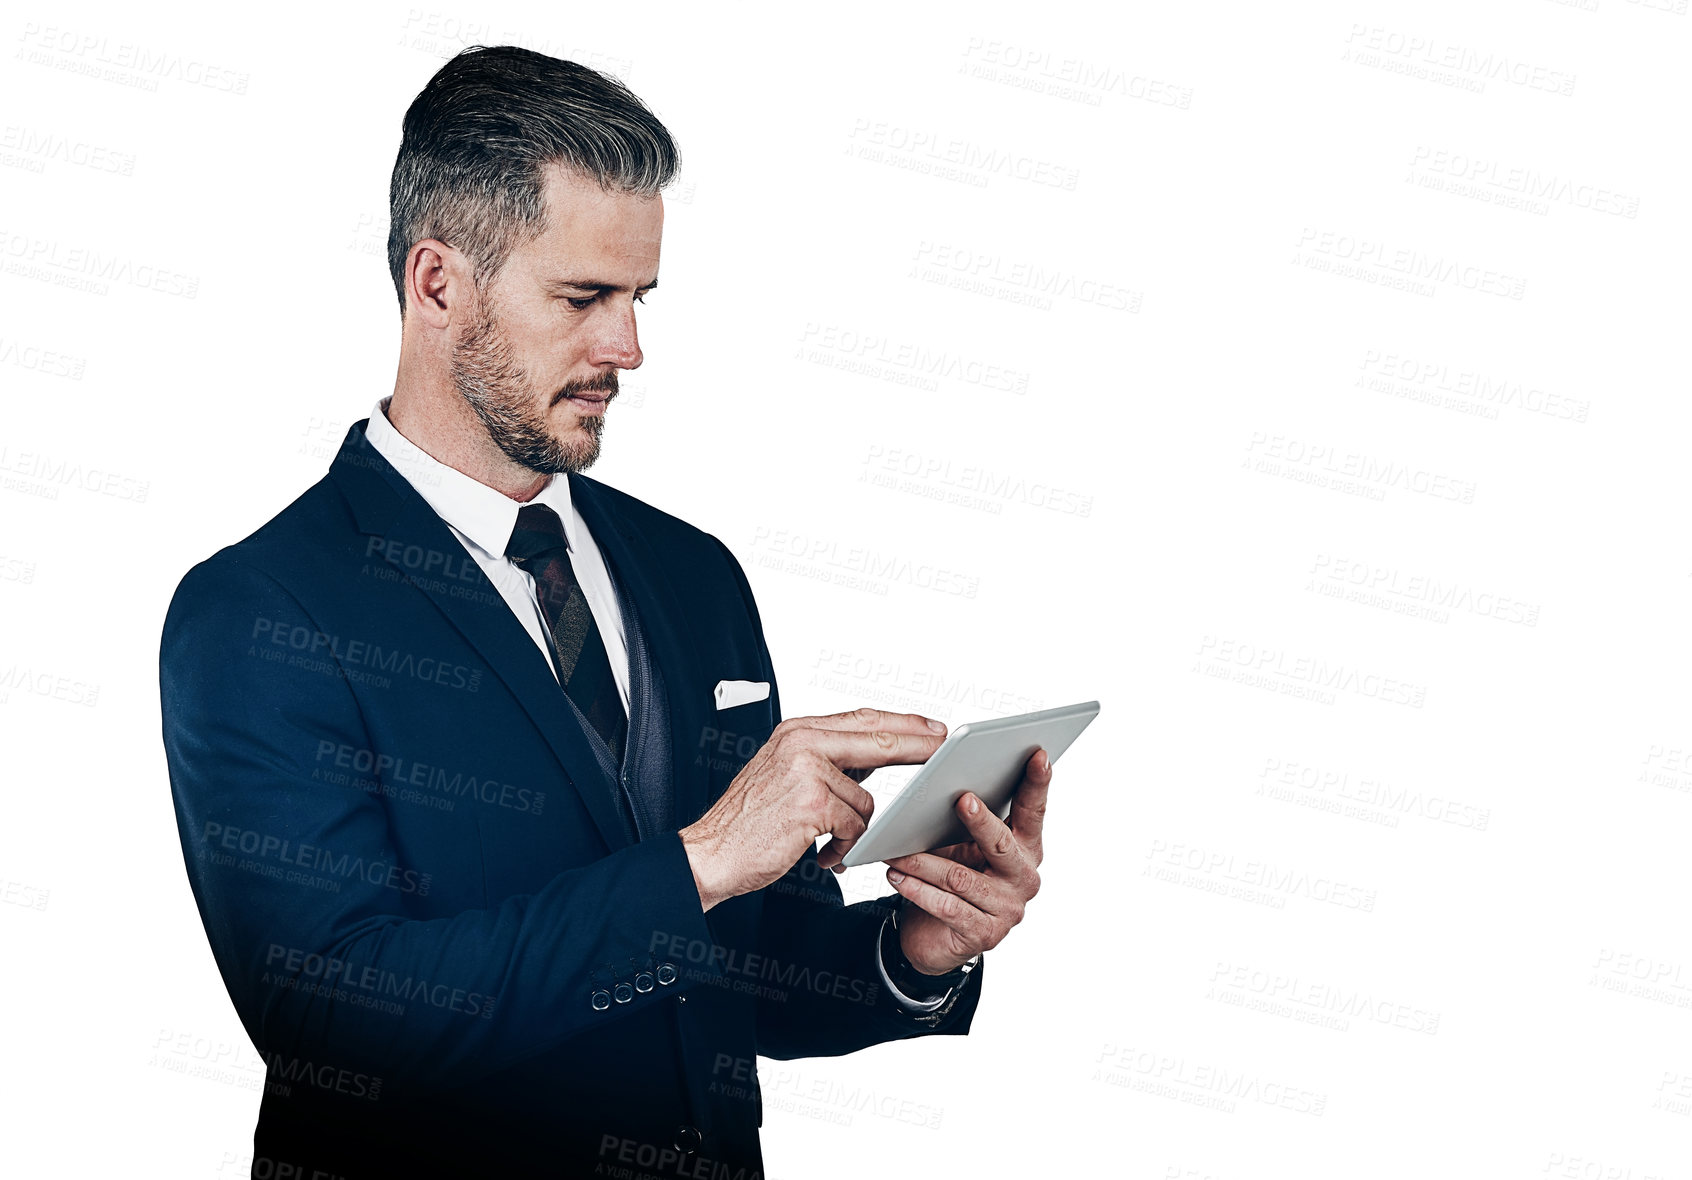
[387,46,680,318]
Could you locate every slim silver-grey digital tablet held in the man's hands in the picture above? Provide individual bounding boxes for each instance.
[841,701,1098,868]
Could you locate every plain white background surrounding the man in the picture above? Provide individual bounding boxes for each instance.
[0,0,1692,1180]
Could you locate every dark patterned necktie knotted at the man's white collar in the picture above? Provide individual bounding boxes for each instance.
[506,505,629,765]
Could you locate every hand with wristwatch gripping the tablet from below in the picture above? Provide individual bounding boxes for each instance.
[887,750,1052,975]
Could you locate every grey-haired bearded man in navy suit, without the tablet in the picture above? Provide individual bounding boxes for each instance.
[161,47,1051,1178]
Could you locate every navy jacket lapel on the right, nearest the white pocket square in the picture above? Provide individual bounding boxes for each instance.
[570,476,711,828]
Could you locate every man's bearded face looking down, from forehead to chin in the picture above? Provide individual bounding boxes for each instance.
[452,166,663,474]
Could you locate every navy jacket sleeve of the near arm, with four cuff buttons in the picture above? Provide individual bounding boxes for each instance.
[159,550,734,1087]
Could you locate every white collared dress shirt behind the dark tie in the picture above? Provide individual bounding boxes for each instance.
[365,398,629,714]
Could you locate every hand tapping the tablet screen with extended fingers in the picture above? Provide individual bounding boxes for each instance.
[682,708,946,911]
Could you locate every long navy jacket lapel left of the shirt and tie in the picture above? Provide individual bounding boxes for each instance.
[330,420,646,850]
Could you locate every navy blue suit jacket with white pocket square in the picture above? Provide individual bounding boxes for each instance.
[161,422,981,1178]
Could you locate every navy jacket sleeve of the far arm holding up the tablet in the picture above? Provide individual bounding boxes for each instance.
[703,542,986,1060]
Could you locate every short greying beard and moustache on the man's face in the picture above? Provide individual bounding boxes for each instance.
[450,296,618,476]
